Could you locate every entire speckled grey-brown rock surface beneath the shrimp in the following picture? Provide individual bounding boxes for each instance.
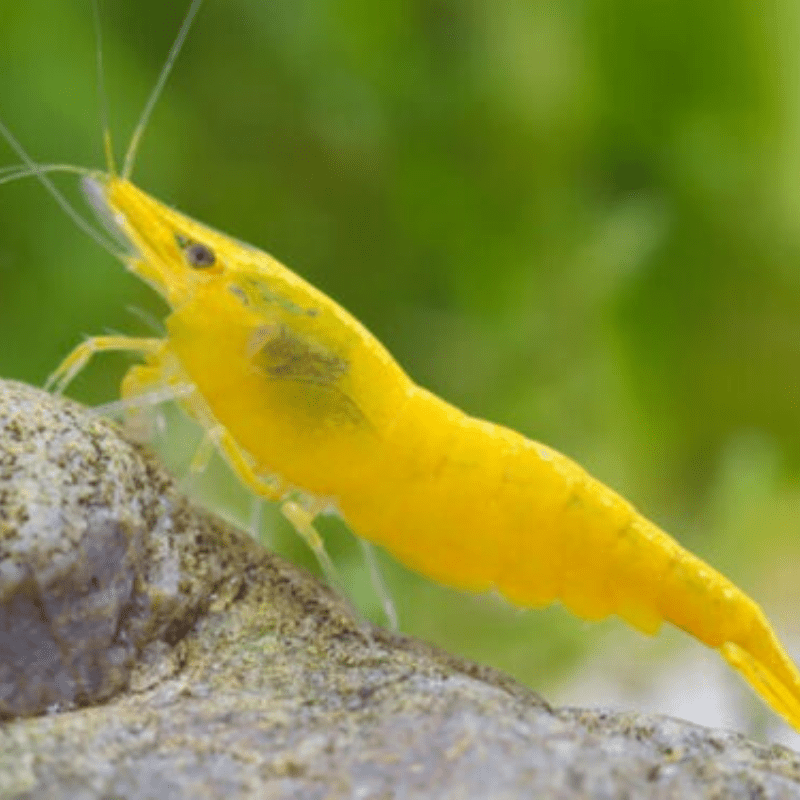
[0,381,800,800]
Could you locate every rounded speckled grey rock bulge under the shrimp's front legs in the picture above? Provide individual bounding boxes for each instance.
[0,382,250,718]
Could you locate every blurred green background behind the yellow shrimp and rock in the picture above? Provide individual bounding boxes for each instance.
[0,0,800,735]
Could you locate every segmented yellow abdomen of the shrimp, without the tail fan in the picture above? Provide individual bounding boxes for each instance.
[340,382,747,647]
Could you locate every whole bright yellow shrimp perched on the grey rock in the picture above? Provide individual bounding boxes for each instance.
[4,0,800,730]
